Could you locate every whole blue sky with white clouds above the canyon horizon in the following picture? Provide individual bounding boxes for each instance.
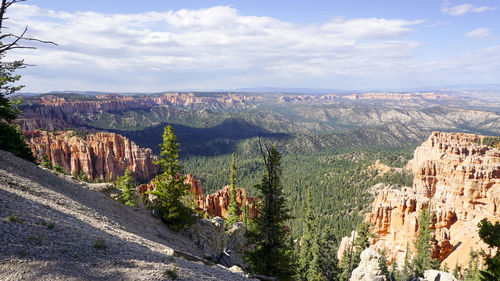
[3,0,500,93]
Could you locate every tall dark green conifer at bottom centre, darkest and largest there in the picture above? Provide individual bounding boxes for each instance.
[246,144,295,280]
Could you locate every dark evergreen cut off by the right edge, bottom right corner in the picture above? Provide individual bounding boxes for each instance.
[478,219,500,281]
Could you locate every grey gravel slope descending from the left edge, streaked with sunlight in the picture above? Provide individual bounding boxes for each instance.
[0,148,252,280]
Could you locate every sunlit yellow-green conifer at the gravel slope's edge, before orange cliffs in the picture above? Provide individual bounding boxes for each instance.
[149,125,194,230]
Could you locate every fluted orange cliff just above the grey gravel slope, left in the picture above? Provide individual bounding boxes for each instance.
[26,130,158,181]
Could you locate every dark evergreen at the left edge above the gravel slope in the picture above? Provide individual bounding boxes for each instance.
[0,0,35,162]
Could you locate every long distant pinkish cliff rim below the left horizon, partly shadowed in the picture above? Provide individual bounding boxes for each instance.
[19,93,253,131]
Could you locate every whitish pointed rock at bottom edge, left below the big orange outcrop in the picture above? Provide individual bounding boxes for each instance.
[350,248,386,281]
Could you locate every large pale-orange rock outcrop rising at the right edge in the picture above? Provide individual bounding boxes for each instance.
[366,132,500,267]
